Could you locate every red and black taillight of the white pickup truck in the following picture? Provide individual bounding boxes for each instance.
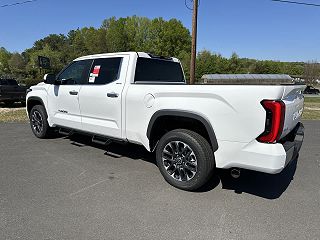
[257,100,286,143]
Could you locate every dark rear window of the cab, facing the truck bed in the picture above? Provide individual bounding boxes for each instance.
[134,58,185,83]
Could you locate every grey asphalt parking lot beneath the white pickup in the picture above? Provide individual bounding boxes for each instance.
[0,121,320,239]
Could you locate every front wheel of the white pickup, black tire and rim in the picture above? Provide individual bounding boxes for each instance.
[29,105,50,138]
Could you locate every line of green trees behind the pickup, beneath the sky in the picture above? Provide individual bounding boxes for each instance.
[0,16,319,85]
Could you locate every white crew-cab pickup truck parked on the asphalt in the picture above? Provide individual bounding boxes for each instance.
[26,52,305,190]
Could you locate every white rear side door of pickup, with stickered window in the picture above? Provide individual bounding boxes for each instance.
[79,55,129,138]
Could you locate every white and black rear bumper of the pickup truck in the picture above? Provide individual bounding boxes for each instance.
[215,123,304,174]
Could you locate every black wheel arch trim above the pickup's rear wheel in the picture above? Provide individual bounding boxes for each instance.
[147,109,218,152]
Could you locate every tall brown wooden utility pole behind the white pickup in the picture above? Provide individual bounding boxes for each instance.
[190,0,199,84]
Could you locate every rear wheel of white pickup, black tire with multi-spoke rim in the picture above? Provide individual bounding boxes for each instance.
[156,129,215,191]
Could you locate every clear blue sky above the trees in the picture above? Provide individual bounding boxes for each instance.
[0,0,320,61]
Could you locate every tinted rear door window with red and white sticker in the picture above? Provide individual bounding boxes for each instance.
[88,57,122,84]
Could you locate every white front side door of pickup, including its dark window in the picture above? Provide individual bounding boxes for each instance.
[48,60,92,130]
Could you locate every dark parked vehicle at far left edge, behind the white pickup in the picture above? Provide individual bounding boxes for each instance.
[0,79,27,105]
